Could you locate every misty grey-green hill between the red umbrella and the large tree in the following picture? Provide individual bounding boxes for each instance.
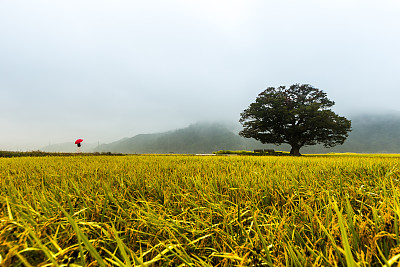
[95,123,268,154]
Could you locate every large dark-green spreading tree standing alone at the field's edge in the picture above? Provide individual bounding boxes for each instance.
[239,84,351,156]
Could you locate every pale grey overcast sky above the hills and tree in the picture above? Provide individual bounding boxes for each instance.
[0,0,400,151]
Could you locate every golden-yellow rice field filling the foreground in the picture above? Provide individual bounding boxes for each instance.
[0,154,400,266]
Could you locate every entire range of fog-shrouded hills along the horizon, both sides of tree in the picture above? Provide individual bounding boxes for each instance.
[41,114,400,154]
